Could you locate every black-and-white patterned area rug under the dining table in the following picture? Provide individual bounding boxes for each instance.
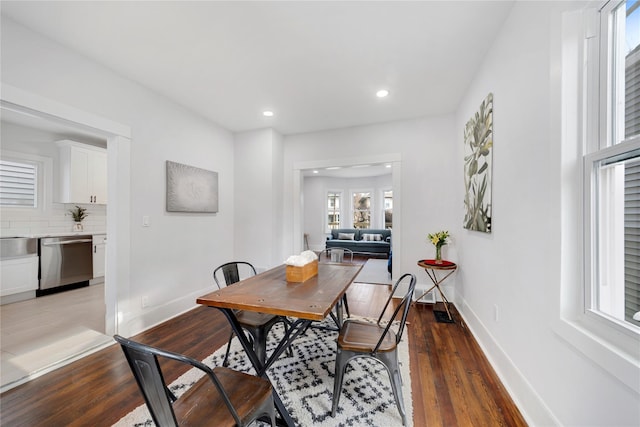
[115,325,413,427]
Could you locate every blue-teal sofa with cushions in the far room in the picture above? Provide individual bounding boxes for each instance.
[325,228,391,257]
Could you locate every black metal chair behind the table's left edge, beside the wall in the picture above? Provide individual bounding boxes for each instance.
[213,261,293,366]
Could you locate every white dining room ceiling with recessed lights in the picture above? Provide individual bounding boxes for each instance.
[1,1,513,135]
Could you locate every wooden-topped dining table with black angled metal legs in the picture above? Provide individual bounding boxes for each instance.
[196,264,362,426]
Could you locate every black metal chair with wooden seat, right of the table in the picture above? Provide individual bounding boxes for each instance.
[331,273,416,425]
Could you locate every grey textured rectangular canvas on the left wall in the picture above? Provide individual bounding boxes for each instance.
[167,160,218,213]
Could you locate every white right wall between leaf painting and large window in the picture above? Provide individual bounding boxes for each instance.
[452,2,640,426]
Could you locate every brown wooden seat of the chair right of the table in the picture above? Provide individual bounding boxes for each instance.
[338,320,397,353]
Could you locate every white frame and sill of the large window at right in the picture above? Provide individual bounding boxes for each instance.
[553,1,640,393]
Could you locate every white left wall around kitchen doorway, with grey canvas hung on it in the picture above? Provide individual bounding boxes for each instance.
[1,17,234,335]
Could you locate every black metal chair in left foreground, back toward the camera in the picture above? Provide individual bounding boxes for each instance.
[113,335,276,427]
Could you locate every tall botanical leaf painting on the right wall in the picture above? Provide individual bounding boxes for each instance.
[464,93,493,233]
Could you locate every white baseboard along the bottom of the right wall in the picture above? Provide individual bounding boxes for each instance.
[458,295,561,426]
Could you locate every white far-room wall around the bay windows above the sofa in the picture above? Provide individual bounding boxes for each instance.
[303,175,393,251]
